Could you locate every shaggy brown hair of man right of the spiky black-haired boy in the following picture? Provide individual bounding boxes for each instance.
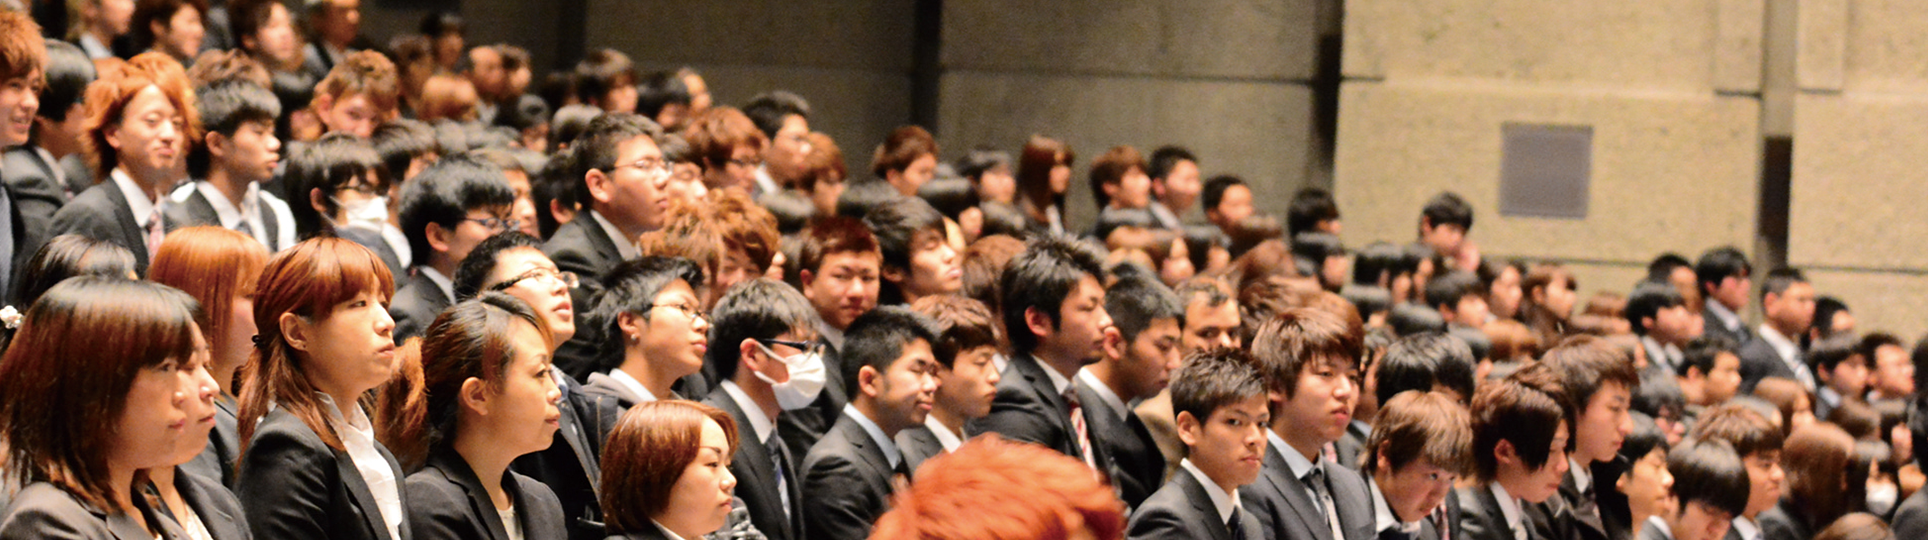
[1251,307,1365,397]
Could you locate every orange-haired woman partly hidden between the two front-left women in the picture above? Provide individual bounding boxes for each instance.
[147,226,268,488]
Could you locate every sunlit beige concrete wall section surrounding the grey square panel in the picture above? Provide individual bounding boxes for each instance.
[1334,0,1764,308]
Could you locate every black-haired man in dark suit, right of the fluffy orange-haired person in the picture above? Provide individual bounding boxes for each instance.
[168,79,296,252]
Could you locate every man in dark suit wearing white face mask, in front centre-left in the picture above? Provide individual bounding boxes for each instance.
[704,280,827,540]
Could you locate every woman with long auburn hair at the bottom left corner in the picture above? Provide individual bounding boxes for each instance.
[0,276,214,538]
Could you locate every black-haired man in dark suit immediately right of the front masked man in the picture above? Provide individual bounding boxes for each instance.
[802,307,943,540]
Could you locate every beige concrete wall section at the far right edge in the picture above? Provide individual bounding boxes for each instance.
[1787,0,1928,338]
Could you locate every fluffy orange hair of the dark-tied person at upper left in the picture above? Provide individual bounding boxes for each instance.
[81,52,201,181]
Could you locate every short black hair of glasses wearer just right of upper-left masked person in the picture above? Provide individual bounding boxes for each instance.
[401,154,515,264]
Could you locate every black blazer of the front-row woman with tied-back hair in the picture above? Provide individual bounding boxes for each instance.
[407,449,569,540]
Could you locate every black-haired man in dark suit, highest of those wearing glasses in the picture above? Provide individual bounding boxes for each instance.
[542,114,669,378]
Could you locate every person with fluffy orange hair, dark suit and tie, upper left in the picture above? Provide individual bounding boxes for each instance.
[48,52,201,274]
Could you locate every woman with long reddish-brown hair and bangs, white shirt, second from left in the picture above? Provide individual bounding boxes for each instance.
[235,237,409,540]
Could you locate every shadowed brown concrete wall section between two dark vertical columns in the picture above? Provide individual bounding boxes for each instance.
[937,0,1319,230]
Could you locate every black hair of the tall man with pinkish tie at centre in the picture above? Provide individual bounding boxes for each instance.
[999,235,1105,355]
